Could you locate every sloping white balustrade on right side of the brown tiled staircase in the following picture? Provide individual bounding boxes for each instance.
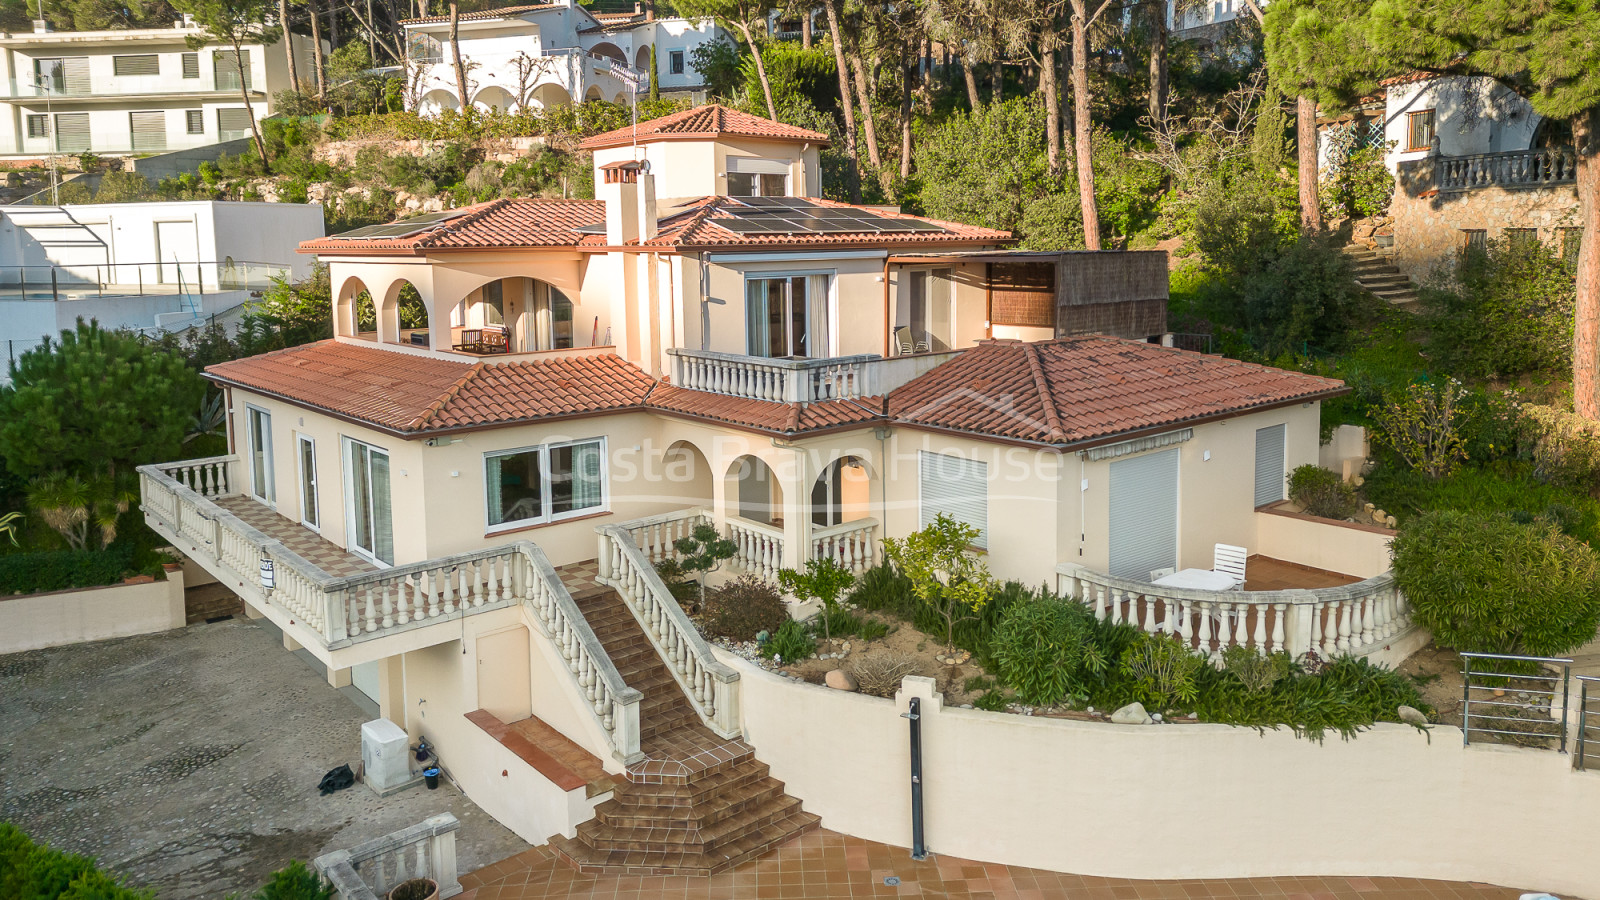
[595,525,739,738]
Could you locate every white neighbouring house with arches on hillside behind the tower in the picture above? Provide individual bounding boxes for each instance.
[403,0,722,115]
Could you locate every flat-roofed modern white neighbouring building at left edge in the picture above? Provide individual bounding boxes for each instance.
[0,200,323,371]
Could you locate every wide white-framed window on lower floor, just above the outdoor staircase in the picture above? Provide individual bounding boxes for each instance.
[483,437,610,532]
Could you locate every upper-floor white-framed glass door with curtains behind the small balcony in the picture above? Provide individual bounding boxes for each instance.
[744,272,837,359]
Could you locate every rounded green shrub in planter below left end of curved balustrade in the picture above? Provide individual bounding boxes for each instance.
[990,597,1107,705]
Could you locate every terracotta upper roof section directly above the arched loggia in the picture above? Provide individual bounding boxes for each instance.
[299,197,605,256]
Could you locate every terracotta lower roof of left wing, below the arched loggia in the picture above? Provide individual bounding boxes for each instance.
[206,341,653,434]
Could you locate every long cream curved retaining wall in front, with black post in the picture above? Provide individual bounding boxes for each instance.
[718,652,1600,897]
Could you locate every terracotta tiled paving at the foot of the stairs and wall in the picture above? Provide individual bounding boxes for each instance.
[461,830,1518,900]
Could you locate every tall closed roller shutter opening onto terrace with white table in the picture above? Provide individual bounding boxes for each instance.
[1110,450,1178,581]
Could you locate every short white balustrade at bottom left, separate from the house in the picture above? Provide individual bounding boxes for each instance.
[312,812,461,900]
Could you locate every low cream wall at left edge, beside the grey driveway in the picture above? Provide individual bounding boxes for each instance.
[0,565,184,653]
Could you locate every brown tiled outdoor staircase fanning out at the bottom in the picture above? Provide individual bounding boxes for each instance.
[550,588,821,874]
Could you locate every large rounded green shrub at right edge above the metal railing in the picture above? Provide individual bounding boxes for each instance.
[1394,512,1600,657]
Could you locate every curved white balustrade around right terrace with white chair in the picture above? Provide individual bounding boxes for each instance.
[1056,562,1413,658]
